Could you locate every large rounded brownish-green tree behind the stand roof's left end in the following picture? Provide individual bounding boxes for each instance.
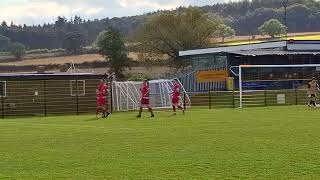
[133,7,221,65]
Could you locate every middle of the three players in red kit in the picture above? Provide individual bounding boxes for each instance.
[137,80,154,118]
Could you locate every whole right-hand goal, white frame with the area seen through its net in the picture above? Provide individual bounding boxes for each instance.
[230,64,320,108]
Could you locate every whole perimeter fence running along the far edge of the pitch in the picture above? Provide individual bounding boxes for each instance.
[0,79,308,118]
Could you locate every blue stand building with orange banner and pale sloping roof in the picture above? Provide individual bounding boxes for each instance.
[179,40,320,92]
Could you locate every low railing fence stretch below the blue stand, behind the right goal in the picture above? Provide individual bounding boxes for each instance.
[189,89,308,109]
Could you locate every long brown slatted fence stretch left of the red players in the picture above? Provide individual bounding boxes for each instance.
[0,79,110,118]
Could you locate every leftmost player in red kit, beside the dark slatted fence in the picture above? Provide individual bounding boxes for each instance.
[96,80,110,118]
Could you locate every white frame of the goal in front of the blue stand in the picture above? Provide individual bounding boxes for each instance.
[230,64,320,108]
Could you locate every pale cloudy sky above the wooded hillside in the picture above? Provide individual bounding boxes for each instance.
[0,0,239,25]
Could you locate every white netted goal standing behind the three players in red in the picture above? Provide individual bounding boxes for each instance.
[112,79,191,111]
